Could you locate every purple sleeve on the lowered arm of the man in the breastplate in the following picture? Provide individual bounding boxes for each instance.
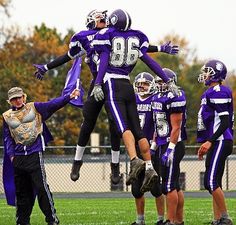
[3,119,16,158]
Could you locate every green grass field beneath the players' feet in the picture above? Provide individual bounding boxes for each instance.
[0,197,236,225]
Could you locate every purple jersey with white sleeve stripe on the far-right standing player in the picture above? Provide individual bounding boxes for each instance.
[197,85,234,143]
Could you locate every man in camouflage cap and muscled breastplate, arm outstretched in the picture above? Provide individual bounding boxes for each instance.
[3,87,79,225]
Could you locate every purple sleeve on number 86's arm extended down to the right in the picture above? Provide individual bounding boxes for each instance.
[140,54,169,83]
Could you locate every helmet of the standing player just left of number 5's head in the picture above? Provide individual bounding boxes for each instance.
[133,72,155,96]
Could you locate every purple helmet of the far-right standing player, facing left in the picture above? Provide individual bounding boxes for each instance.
[198,60,227,86]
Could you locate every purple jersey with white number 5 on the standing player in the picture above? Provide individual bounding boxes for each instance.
[152,90,187,145]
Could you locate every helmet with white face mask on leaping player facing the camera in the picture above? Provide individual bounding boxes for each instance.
[85,9,107,30]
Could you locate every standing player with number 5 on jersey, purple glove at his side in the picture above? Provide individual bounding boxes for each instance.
[152,68,187,225]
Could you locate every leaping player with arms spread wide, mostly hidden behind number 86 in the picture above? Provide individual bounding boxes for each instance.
[34,10,178,184]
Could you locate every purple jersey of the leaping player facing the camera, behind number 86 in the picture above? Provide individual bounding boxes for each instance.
[68,29,99,78]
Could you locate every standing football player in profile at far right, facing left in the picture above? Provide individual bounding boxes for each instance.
[197,60,234,225]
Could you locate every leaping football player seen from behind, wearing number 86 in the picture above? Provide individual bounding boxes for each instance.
[92,9,179,192]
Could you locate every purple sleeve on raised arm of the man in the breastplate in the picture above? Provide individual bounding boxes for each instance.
[34,94,70,121]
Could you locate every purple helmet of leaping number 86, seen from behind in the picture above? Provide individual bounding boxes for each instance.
[109,9,132,31]
